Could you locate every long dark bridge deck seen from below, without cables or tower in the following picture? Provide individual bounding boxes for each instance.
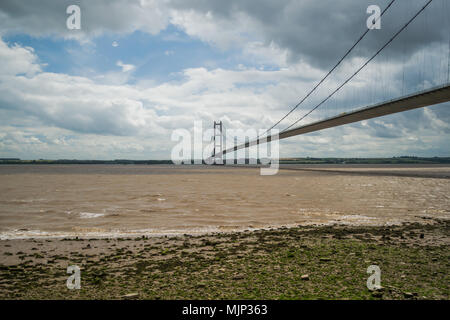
[223,84,450,154]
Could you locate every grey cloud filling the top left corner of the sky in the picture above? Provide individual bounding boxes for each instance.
[0,0,168,39]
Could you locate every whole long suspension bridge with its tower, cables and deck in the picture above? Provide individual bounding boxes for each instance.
[211,0,450,163]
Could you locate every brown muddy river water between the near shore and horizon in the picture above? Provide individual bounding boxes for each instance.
[0,165,450,239]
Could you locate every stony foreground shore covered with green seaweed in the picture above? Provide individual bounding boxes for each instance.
[0,218,450,300]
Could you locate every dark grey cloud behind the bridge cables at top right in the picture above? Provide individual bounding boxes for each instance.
[170,0,448,67]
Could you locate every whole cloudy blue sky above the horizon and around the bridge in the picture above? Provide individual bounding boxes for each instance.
[0,0,450,159]
